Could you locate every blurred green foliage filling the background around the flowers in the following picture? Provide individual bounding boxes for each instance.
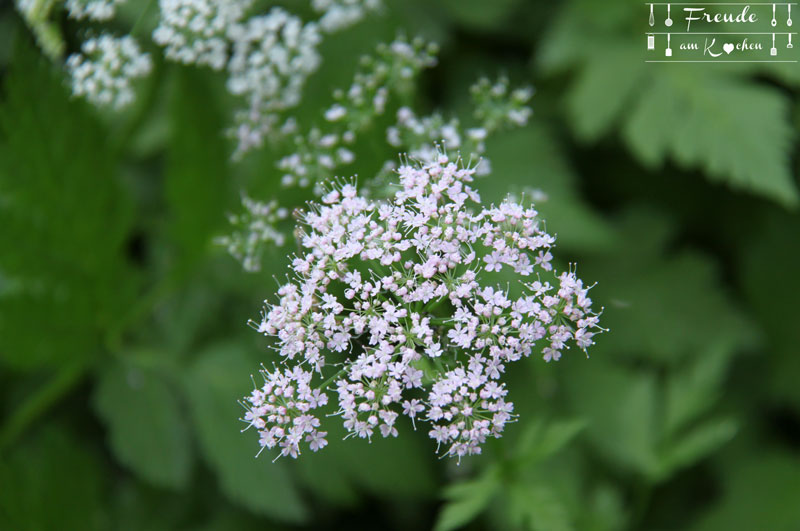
[0,0,800,531]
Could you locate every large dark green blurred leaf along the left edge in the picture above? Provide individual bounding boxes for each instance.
[0,39,136,369]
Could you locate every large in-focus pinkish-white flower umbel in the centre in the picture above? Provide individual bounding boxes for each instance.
[245,154,602,458]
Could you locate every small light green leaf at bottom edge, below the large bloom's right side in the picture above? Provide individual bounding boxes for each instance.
[434,471,500,531]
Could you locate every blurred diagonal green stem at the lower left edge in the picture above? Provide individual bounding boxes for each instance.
[0,361,89,451]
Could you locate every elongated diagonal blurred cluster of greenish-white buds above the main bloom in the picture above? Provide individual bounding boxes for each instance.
[278,37,437,186]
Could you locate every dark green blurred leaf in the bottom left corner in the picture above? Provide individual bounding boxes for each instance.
[0,424,107,531]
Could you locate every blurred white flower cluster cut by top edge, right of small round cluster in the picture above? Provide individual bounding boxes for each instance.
[153,0,253,70]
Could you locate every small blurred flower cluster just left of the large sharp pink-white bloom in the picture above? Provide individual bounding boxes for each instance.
[215,196,289,272]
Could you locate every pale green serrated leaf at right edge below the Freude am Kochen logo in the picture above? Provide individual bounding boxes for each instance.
[623,71,798,207]
